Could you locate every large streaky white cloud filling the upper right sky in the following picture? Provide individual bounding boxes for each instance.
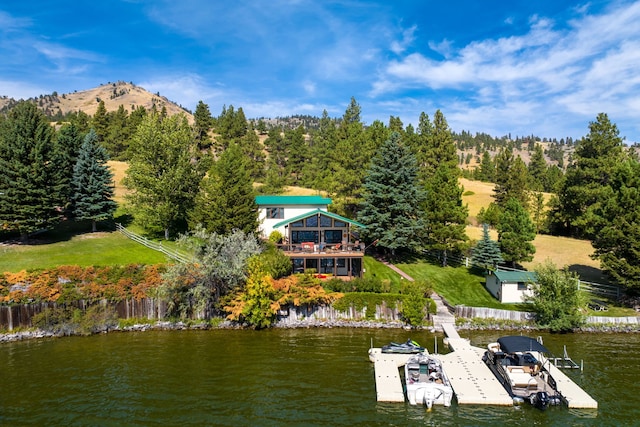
[370,2,640,140]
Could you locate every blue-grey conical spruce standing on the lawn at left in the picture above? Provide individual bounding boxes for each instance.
[72,129,117,231]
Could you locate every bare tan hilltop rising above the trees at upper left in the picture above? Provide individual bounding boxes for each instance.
[0,81,193,121]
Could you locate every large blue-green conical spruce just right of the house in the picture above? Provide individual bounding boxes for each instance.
[358,132,425,253]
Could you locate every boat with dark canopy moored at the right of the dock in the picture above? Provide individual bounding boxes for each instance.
[483,336,566,409]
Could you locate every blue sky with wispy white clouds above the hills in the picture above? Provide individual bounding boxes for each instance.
[0,0,640,142]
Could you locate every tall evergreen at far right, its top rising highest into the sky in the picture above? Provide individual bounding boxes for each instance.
[554,113,626,238]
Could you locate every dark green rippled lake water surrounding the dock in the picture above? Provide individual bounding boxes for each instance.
[0,329,640,426]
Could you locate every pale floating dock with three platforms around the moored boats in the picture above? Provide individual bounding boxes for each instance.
[369,323,598,409]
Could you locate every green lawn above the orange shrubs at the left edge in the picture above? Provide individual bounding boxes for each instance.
[0,232,167,272]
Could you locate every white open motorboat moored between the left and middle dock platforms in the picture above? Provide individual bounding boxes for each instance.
[404,352,453,409]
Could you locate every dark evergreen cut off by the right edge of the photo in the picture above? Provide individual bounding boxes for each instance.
[592,158,640,292]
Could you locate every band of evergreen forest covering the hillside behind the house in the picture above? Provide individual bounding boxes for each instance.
[0,83,640,294]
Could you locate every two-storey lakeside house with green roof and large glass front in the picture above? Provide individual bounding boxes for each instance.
[256,196,364,279]
